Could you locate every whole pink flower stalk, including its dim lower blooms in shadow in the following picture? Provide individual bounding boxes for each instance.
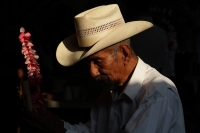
[19,27,44,111]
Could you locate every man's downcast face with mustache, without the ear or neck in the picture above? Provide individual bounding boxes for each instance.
[88,49,124,89]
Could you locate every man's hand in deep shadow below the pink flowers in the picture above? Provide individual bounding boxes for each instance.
[23,109,66,133]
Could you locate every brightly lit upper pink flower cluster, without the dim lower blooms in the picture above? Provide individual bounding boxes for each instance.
[19,27,42,86]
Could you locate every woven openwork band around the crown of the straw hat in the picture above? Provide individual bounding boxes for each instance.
[77,18,125,37]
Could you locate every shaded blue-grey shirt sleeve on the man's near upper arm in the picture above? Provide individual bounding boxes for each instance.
[125,88,185,133]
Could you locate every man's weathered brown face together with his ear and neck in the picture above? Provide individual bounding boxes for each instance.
[87,45,137,89]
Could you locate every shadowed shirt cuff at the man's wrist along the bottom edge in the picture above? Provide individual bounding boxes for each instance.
[63,121,93,133]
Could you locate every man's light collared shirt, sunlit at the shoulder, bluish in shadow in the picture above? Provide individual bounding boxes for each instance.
[64,57,185,133]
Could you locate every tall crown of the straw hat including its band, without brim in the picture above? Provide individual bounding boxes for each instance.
[74,4,125,47]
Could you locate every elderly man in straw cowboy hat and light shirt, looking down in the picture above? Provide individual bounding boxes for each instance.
[22,4,185,133]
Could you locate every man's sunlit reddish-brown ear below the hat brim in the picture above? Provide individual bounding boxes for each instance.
[120,44,132,62]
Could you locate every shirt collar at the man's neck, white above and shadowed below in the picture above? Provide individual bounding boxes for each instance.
[123,57,147,101]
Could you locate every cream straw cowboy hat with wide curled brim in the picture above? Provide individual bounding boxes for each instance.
[56,4,153,66]
